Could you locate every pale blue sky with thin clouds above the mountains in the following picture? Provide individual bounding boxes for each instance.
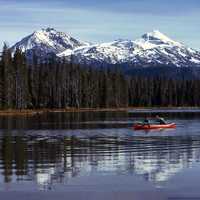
[0,0,200,49]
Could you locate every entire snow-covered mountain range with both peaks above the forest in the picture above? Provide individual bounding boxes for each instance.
[12,28,200,67]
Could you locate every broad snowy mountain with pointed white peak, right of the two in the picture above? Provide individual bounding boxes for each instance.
[58,31,200,67]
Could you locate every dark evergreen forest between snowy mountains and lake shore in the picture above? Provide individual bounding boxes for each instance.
[0,45,200,109]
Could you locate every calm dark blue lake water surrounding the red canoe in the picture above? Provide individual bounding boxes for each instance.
[0,110,200,194]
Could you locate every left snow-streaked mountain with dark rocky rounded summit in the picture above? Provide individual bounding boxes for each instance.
[11,28,88,57]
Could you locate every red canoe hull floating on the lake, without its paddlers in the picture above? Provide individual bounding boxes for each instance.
[133,123,176,130]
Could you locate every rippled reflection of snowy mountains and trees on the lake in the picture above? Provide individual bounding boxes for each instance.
[0,130,200,189]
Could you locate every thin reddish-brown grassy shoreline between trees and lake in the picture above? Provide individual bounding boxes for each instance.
[0,107,200,116]
